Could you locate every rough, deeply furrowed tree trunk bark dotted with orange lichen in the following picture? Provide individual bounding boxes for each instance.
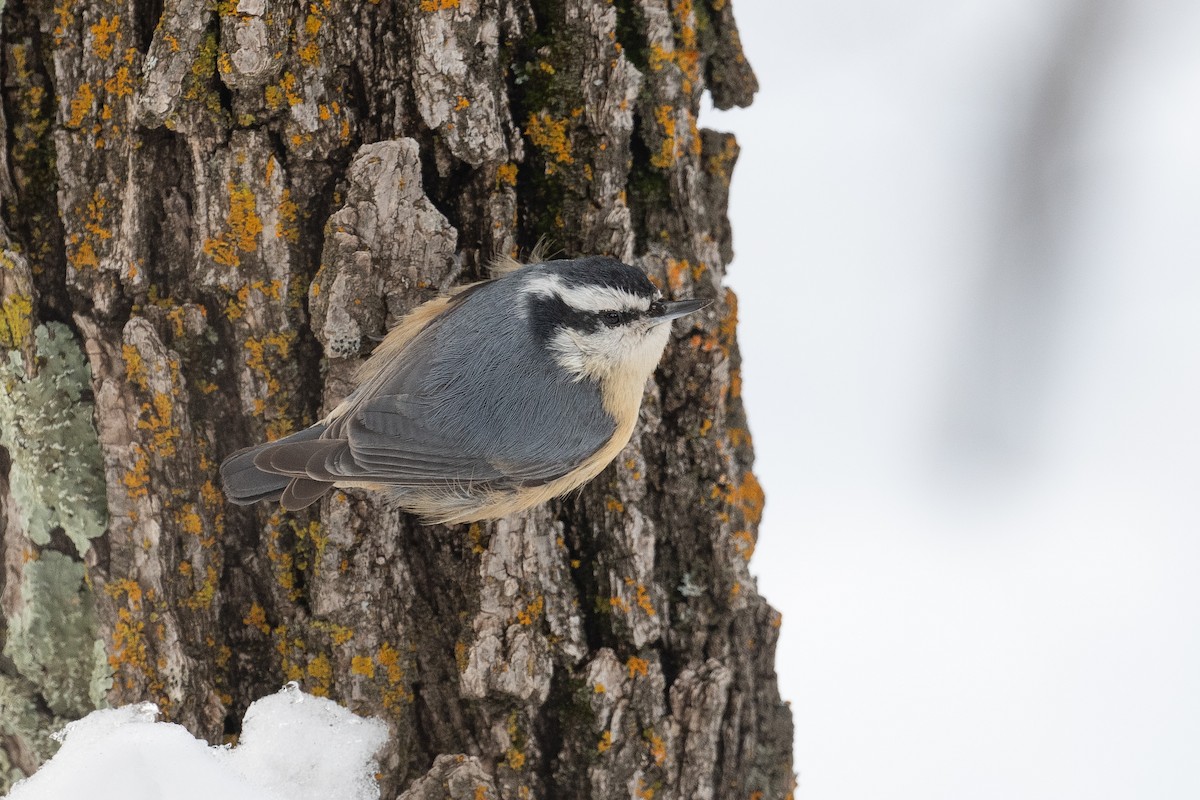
[0,0,792,799]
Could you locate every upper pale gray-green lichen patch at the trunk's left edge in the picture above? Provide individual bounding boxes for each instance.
[0,323,108,555]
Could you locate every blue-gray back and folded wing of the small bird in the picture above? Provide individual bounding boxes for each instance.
[305,272,616,487]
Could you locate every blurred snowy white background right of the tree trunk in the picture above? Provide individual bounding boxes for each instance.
[701,0,1200,800]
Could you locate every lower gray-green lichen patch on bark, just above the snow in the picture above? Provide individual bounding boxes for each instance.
[4,551,112,720]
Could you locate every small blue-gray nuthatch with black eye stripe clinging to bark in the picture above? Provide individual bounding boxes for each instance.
[221,255,710,524]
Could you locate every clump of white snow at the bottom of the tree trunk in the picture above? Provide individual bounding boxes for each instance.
[8,684,388,800]
